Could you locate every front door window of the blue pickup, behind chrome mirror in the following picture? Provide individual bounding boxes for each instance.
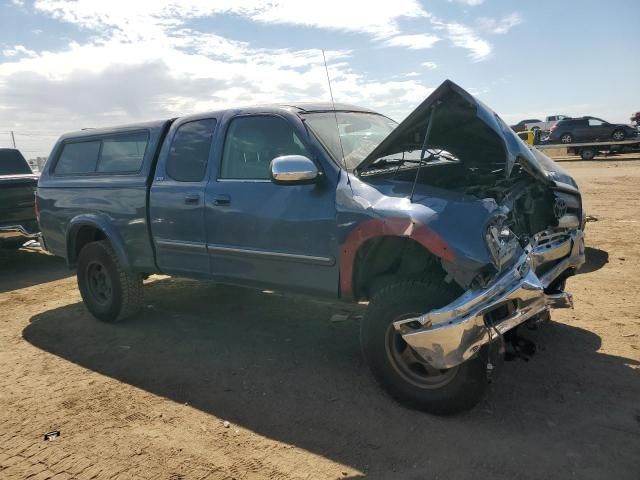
[220,115,310,180]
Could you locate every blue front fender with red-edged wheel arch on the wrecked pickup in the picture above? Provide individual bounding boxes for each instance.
[336,172,498,298]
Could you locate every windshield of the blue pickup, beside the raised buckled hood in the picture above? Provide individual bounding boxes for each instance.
[304,112,398,171]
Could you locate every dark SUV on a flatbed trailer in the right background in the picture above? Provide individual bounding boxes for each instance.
[549,117,636,143]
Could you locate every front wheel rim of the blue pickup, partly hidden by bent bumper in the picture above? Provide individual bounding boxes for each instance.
[386,314,458,389]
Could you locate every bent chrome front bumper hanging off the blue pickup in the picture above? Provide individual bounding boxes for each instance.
[393,230,585,369]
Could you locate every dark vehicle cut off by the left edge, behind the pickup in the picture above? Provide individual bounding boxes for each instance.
[0,148,38,247]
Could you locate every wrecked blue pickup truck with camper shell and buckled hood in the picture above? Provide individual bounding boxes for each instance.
[37,81,584,414]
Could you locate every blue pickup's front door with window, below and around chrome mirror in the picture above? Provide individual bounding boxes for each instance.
[205,115,338,295]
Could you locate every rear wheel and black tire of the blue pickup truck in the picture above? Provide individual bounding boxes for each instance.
[77,240,142,322]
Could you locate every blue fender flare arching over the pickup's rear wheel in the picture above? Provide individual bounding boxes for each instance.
[66,214,131,269]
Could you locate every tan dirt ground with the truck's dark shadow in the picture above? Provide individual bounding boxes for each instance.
[0,155,640,480]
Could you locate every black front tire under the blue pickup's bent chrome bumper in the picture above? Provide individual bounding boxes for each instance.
[360,280,490,415]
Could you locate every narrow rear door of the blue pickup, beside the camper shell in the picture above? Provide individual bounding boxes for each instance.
[149,118,217,276]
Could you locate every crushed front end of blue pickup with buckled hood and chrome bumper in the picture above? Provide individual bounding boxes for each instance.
[355,81,585,369]
